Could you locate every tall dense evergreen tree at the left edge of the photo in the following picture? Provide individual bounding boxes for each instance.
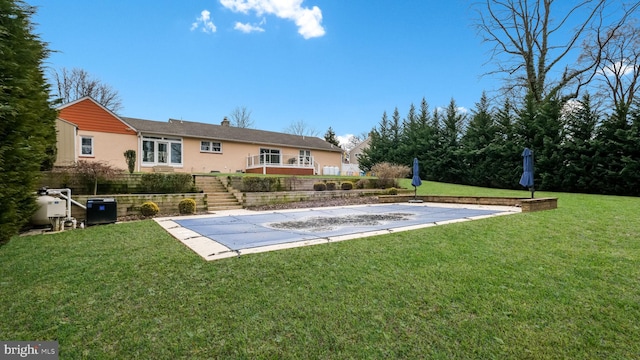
[0,0,57,243]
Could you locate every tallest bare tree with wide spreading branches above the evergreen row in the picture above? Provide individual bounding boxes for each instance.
[477,0,640,102]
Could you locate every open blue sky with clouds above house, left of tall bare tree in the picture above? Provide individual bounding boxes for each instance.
[27,0,498,143]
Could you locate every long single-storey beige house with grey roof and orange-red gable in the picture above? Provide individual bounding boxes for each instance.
[56,97,342,175]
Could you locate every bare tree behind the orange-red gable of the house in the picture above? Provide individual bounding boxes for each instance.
[53,68,122,113]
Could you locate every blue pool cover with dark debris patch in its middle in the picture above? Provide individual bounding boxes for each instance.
[173,204,504,250]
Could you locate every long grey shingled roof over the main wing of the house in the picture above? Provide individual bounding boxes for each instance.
[121,117,342,152]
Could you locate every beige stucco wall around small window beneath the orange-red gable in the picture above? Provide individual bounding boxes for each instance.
[76,130,138,170]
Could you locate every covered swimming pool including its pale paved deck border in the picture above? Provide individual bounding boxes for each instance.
[155,203,521,261]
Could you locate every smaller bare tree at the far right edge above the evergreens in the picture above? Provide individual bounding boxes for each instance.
[581,19,640,114]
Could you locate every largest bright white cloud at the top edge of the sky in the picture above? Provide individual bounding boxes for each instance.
[220,0,325,39]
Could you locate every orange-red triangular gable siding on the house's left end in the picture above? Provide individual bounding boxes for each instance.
[58,99,135,135]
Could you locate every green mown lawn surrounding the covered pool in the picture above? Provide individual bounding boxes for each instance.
[0,182,640,359]
